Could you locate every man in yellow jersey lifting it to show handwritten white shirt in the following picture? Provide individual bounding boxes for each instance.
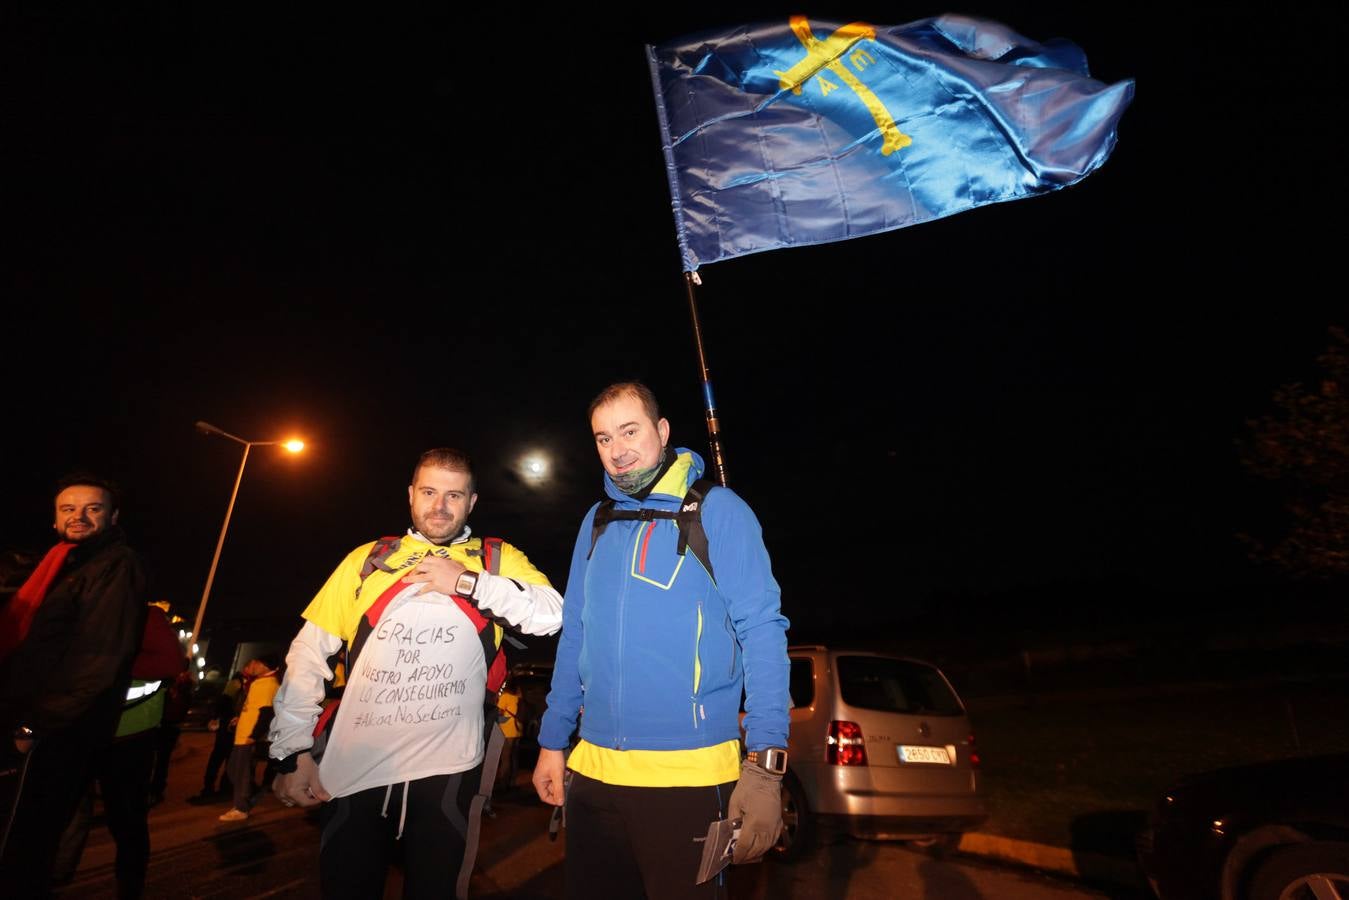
[271,448,563,900]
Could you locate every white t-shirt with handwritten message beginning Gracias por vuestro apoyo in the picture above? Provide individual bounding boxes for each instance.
[318,584,487,797]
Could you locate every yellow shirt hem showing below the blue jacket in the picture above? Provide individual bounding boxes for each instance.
[567,741,741,788]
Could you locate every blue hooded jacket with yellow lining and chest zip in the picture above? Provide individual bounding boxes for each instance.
[538,448,789,750]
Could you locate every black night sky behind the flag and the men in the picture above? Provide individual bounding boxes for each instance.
[0,1,1349,647]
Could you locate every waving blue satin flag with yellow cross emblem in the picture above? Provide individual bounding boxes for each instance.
[646,15,1133,271]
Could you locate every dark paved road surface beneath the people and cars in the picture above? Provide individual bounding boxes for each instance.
[61,733,1130,900]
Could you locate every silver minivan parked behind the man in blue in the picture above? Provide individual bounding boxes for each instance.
[776,646,987,860]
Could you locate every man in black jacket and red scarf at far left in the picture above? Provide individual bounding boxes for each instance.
[0,474,147,897]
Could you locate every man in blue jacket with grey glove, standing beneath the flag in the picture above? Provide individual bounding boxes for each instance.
[534,382,789,899]
